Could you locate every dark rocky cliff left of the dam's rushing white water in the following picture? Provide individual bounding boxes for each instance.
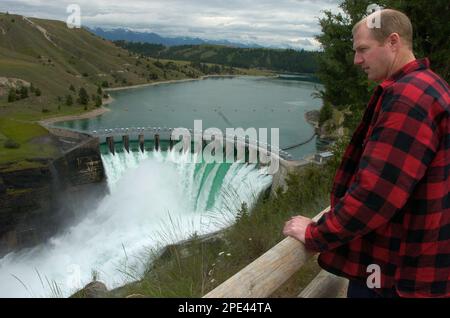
[0,131,106,256]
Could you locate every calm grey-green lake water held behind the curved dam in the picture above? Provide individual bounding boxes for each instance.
[55,75,321,158]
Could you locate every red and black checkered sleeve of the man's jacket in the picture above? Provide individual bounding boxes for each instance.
[305,101,439,252]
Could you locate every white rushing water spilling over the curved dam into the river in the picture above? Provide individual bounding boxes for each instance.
[0,152,272,297]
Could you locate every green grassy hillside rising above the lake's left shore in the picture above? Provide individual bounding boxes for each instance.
[0,14,188,119]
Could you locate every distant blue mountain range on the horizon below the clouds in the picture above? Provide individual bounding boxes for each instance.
[89,27,261,48]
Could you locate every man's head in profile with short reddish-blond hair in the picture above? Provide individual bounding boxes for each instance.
[352,9,413,81]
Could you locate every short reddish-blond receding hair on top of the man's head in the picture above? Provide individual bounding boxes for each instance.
[352,9,413,50]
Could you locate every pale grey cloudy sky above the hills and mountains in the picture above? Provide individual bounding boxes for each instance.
[0,0,340,49]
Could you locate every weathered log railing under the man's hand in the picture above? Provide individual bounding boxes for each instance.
[203,207,346,298]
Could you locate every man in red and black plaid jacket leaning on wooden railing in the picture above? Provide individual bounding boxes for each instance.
[283,9,450,297]
